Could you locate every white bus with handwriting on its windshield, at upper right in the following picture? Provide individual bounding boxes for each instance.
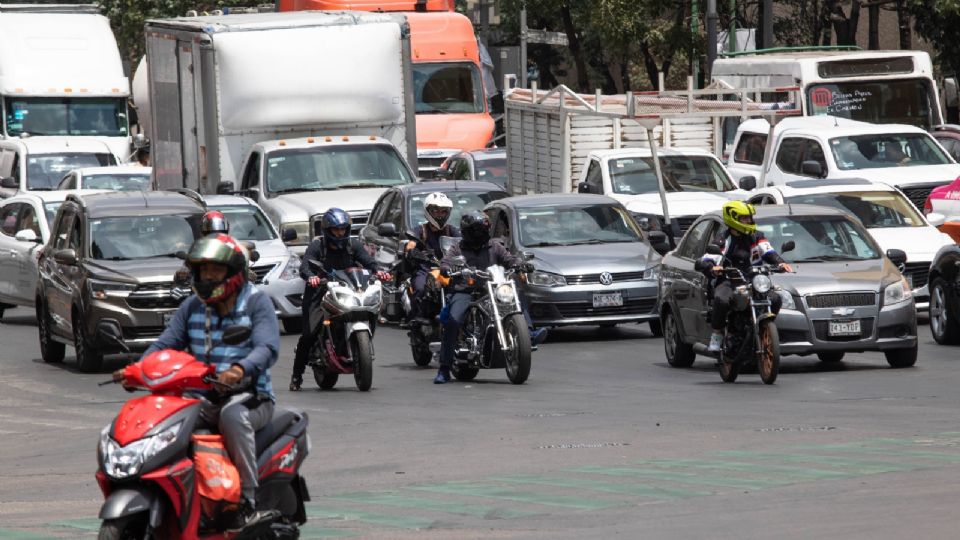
[712,48,943,130]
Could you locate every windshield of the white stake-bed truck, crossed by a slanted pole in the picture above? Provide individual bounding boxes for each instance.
[609,156,736,195]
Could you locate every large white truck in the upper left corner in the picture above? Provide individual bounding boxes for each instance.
[0,4,131,160]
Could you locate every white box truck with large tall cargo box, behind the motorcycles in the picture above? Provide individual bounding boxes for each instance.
[137,12,416,251]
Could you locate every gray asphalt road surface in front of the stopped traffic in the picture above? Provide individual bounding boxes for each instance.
[0,309,960,539]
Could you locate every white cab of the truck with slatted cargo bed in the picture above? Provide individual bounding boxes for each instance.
[577,148,747,238]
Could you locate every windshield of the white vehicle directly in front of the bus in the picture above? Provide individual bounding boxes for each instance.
[830,133,950,171]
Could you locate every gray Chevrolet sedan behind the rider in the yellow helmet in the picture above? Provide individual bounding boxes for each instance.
[659,204,917,367]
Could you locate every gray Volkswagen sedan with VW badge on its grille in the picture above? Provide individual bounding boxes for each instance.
[485,194,660,335]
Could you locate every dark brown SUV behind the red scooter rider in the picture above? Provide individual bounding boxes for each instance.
[36,191,204,372]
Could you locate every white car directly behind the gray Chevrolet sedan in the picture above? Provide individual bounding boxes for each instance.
[748,179,954,311]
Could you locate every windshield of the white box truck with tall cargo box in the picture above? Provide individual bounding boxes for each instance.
[267,144,413,193]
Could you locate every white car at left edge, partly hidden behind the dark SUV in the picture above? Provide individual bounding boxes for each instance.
[0,190,108,317]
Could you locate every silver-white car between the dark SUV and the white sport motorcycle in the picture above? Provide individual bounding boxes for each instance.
[203,195,304,333]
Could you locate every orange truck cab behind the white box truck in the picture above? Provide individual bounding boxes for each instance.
[281,0,495,178]
